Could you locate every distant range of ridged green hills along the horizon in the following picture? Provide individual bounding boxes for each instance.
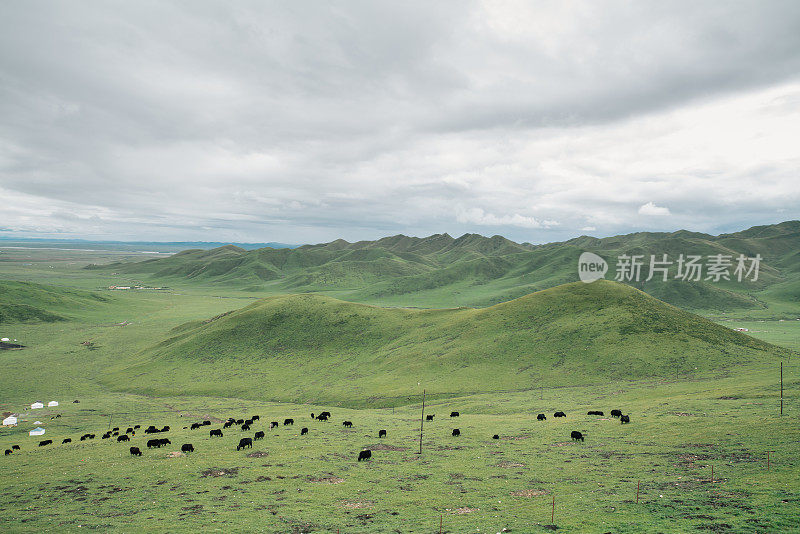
[88,221,800,315]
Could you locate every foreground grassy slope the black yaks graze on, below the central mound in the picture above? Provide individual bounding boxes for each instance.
[0,362,800,533]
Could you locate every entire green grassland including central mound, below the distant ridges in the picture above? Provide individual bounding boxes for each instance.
[0,246,800,533]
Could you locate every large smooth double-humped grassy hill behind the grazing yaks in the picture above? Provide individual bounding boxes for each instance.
[105,281,784,405]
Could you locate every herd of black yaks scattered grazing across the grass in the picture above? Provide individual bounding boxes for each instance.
[5,410,630,462]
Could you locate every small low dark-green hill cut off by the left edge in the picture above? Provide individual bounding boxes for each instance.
[0,280,108,323]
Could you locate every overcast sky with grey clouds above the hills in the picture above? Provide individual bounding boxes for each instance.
[0,0,800,243]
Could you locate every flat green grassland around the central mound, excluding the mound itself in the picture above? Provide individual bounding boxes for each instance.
[0,249,800,533]
